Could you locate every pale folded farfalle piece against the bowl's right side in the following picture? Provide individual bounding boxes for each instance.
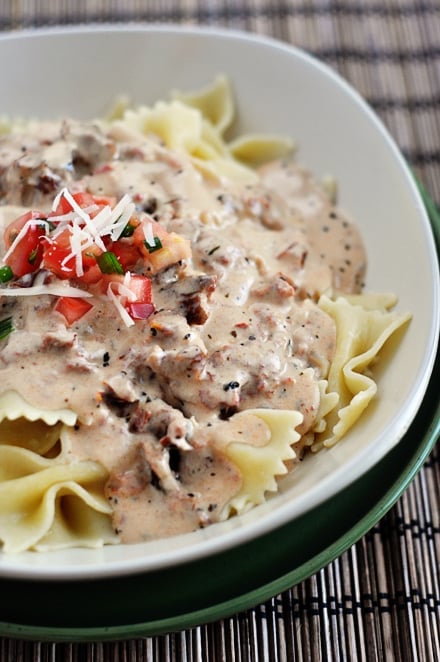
[312,294,411,451]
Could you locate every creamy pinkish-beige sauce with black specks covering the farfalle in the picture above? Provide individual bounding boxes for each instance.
[0,121,365,542]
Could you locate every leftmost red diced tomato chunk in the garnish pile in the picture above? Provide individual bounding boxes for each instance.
[4,211,46,277]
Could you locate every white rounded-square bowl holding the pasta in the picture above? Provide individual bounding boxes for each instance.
[0,25,439,579]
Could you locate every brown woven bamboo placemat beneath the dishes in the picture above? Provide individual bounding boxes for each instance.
[0,0,440,662]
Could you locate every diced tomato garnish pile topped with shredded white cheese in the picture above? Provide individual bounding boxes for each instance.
[2,190,191,325]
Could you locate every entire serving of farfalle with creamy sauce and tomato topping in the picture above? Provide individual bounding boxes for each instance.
[0,23,436,580]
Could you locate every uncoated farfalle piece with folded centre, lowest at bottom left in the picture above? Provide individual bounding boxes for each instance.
[0,446,117,553]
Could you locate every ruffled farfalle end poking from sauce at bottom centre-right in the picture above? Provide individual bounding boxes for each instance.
[221,409,303,519]
